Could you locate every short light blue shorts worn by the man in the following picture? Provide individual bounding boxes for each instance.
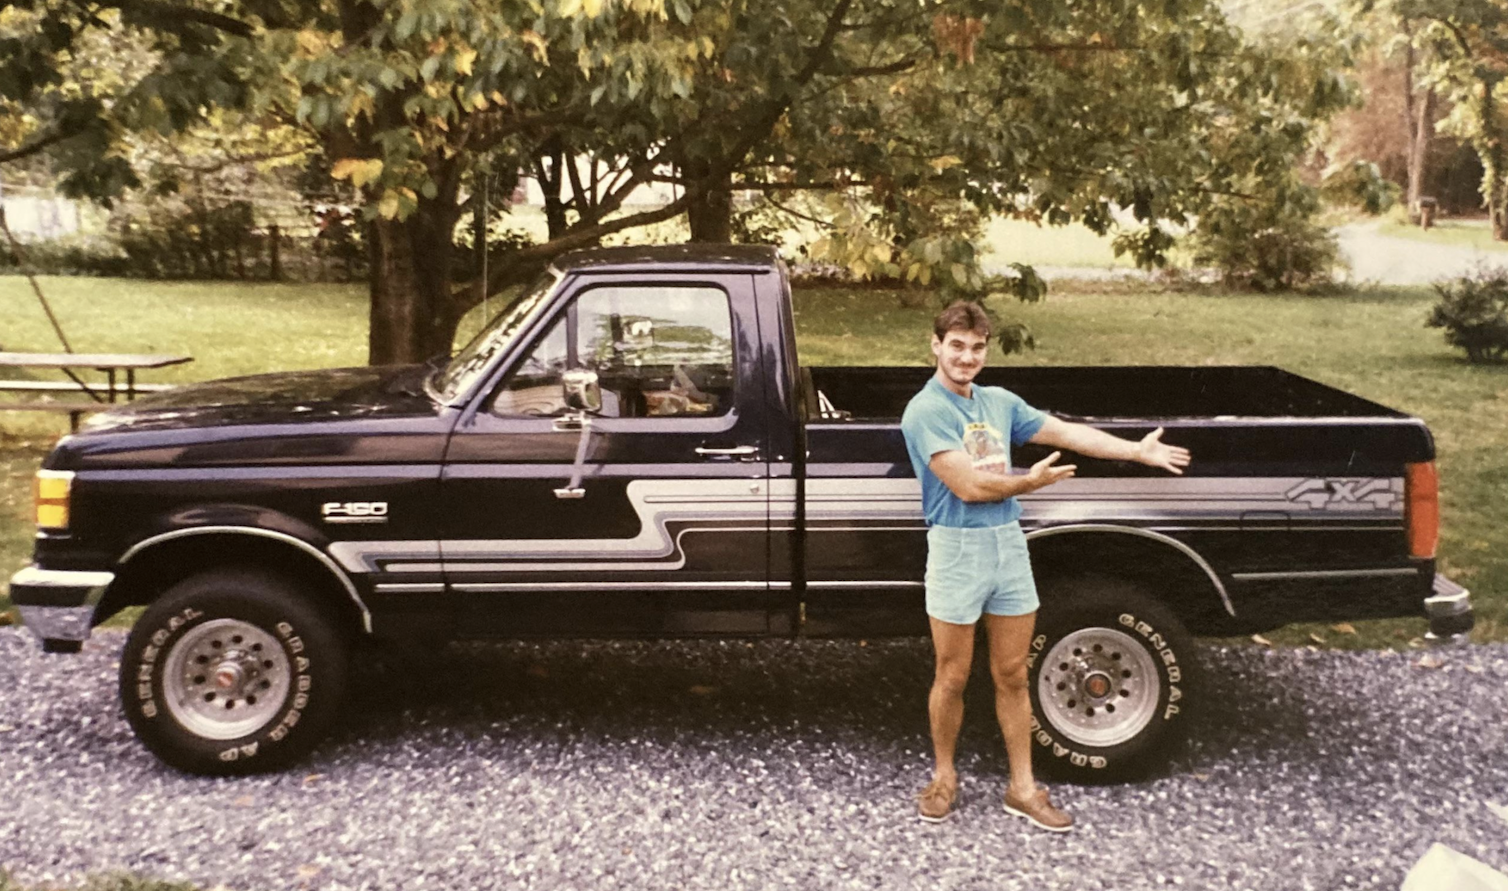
[926,522,1039,626]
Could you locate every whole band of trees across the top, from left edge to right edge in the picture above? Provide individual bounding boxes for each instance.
[0,0,1508,362]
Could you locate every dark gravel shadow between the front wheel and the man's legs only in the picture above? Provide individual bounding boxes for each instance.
[341,641,932,743]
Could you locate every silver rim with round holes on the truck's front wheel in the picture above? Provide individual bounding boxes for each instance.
[163,618,291,740]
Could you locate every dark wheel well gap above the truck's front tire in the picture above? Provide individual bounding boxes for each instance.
[93,532,365,633]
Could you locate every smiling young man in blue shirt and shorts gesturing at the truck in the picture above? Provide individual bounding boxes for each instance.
[900,302,1188,832]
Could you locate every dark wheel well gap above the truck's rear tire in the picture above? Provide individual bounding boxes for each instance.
[1030,531,1235,635]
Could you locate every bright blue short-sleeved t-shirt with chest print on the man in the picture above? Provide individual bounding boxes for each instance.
[900,377,1047,528]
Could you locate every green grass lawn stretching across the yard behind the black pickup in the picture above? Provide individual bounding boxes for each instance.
[0,271,1508,647]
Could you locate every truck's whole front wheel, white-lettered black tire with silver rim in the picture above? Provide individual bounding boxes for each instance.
[121,568,348,776]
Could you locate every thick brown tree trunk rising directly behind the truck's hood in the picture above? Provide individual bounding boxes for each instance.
[368,202,460,365]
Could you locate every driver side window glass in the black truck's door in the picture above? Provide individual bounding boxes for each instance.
[492,285,734,418]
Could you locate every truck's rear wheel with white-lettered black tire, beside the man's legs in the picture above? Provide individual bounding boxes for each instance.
[1027,579,1199,782]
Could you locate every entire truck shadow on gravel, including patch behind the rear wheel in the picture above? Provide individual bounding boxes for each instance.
[333,639,1345,773]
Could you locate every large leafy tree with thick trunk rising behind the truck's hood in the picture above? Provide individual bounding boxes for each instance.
[0,0,1345,362]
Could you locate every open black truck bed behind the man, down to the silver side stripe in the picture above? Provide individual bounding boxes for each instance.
[805,366,1434,476]
